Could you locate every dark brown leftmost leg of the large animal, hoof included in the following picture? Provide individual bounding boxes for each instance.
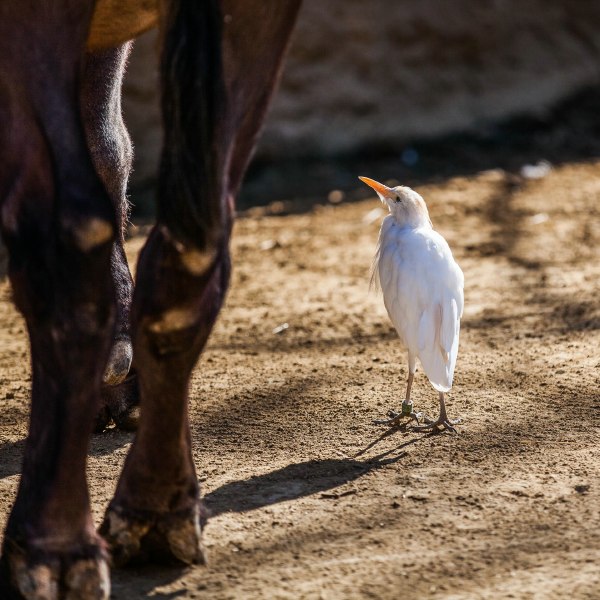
[0,0,117,600]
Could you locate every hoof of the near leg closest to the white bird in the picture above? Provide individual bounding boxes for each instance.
[100,505,206,566]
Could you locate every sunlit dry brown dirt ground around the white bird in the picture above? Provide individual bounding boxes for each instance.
[0,161,600,600]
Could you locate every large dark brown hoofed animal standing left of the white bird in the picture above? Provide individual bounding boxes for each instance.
[0,0,300,600]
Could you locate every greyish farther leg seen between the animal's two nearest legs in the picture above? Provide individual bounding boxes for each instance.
[80,43,138,430]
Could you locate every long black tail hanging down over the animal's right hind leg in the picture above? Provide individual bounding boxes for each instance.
[158,0,225,249]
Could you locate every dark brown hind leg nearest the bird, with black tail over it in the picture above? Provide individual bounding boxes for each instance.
[101,0,299,563]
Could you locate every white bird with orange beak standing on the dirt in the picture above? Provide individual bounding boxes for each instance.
[359,177,464,431]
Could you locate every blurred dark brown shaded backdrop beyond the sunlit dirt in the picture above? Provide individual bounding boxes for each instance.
[124,0,600,217]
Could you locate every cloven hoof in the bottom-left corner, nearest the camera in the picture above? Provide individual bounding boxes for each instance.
[0,542,110,600]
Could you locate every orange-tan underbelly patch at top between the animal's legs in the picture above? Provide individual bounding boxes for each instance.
[87,0,158,50]
